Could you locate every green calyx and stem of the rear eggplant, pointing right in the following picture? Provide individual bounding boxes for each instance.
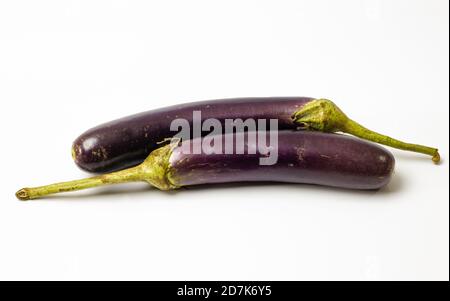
[292,99,440,163]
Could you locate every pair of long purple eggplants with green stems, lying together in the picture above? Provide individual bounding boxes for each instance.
[16,97,440,200]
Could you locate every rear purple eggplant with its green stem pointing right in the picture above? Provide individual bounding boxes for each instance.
[72,97,440,173]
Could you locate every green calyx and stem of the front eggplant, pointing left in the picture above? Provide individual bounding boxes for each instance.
[16,144,179,201]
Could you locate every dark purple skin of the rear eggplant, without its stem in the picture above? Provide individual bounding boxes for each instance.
[72,97,313,173]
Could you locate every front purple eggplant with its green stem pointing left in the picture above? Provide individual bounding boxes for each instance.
[16,130,395,200]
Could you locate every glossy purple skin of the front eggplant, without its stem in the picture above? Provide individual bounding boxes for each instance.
[168,131,395,190]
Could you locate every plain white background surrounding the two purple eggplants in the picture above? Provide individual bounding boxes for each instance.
[0,0,449,280]
